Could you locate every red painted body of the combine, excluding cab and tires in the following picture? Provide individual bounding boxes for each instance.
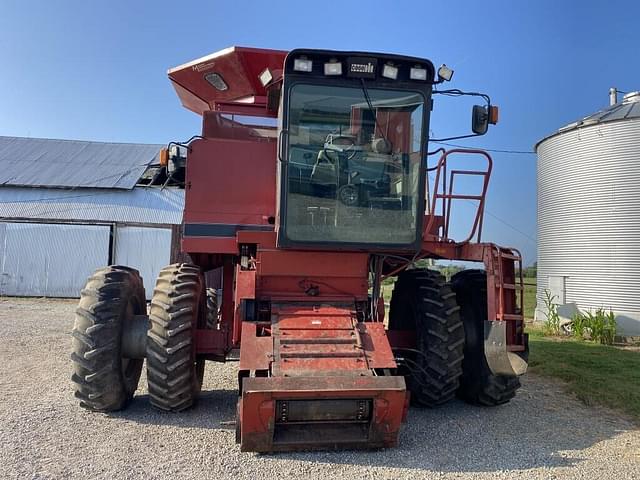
[169,47,524,451]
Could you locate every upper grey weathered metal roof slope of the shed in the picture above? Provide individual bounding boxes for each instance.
[0,136,162,190]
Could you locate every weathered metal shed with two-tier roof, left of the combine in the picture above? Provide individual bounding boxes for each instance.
[0,137,184,297]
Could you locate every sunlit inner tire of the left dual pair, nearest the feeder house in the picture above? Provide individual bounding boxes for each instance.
[147,263,206,412]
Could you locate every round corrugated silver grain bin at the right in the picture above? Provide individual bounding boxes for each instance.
[536,92,640,335]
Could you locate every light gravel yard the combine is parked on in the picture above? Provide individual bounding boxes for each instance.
[0,299,640,480]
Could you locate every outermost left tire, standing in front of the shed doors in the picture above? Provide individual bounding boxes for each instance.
[71,266,147,412]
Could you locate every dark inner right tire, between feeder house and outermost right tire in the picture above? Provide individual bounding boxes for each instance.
[389,270,464,407]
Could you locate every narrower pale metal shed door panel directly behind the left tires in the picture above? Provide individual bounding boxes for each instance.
[114,226,171,300]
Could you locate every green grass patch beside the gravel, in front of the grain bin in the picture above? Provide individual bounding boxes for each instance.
[529,329,640,421]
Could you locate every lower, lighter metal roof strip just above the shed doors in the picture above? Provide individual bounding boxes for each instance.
[0,187,184,225]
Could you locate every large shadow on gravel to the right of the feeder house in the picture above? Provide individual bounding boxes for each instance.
[270,375,635,472]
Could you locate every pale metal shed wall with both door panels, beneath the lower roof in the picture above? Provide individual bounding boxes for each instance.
[0,222,171,299]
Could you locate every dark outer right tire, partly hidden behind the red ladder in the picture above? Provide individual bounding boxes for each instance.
[451,270,520,406]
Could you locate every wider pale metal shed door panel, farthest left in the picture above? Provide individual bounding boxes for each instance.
[0,222,110,297]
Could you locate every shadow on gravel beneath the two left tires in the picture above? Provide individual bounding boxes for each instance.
[109,390,238,430]
